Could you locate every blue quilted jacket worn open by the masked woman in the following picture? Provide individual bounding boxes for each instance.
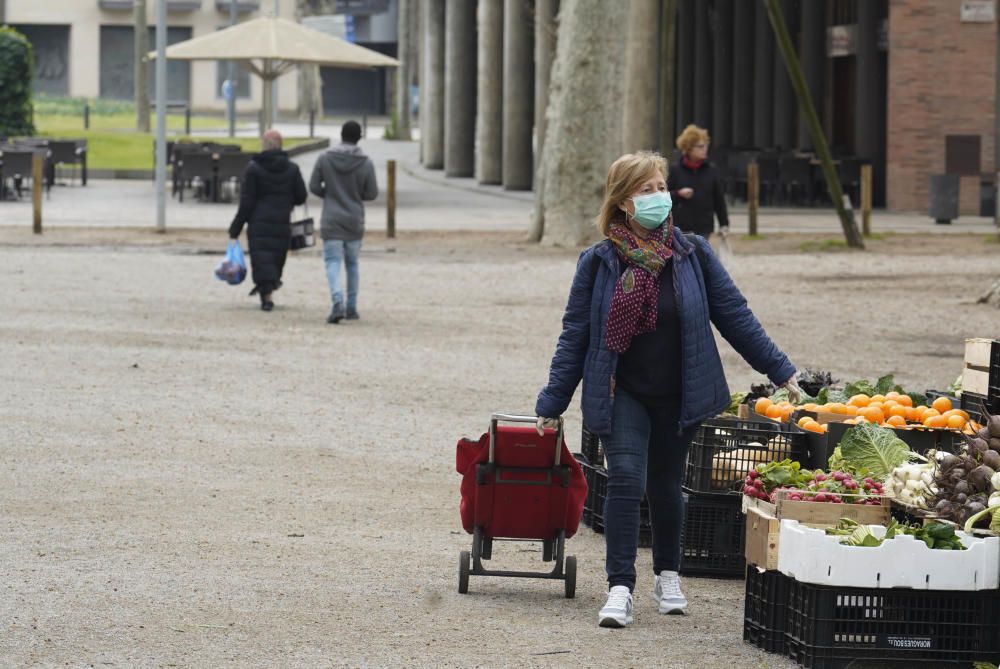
[535,235,795,434]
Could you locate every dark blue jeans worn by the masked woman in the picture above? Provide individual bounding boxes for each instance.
[603,388,698,590]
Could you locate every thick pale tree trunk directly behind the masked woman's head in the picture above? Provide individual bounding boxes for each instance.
[538,0,628,246]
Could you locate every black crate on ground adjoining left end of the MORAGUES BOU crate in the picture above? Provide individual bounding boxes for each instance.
[743,564,791,653]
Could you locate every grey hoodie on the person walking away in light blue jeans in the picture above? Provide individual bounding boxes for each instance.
[309,142,378,241]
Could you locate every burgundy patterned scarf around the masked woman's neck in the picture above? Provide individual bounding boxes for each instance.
[605,218,674,353]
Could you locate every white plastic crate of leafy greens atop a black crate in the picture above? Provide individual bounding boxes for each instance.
[778,520,1000,590]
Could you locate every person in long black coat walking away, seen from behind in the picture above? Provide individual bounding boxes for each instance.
[229,130,306,311]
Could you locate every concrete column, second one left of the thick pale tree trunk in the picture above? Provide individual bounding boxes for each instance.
[503,0,535,190]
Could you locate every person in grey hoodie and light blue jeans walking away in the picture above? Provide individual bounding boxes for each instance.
[309,121,378,323]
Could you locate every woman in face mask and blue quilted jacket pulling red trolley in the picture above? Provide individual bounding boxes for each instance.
[535,151,800,627]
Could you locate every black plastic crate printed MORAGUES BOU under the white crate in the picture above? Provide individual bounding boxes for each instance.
[785,579,1000,669]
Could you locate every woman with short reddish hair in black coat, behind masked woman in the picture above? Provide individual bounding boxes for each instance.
[668,124,729,239]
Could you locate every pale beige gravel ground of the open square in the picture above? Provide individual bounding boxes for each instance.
[0,231,1000,669]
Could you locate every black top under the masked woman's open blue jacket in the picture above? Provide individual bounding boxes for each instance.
[615,261,681,404]
